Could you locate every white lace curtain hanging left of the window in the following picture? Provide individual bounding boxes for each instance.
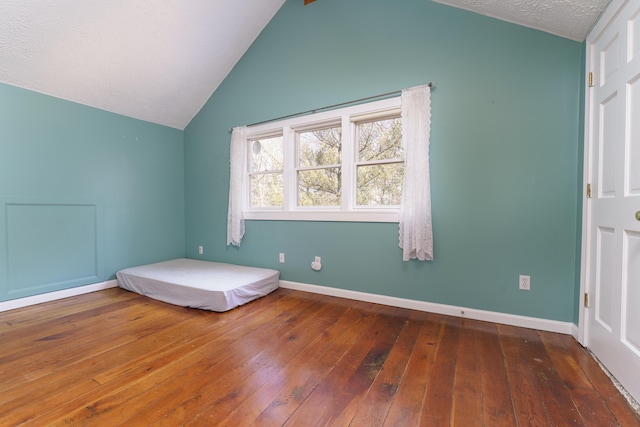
[227,126,247,246]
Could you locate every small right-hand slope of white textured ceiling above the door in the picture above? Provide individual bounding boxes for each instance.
[433,0,610,42]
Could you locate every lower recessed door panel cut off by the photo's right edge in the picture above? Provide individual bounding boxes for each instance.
[622,232,640,356]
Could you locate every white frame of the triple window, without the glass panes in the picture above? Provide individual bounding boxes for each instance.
[243,96,402,223]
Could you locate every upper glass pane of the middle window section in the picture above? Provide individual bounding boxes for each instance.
[298,126,342,168]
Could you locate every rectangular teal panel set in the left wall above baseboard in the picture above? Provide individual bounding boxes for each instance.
[6,204,98,297]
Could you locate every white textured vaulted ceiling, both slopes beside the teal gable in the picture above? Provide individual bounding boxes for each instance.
[0,0,609,129]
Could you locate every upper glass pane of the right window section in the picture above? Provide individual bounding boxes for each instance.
[358,118,404,162]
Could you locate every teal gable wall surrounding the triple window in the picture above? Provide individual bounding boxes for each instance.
[184,0,583,321]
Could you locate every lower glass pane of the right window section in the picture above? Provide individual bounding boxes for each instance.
[357,163,404,206]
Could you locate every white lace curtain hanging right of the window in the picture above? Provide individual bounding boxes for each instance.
[400,85,433,261]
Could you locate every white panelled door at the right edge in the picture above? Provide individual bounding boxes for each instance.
[582,0,640,401]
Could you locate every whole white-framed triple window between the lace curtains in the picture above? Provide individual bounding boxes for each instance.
[244,97,404,222]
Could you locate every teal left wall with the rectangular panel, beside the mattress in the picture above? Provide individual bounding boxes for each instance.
[0,84,185,301]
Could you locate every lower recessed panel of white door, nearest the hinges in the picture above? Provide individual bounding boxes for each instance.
[595,227,615,332]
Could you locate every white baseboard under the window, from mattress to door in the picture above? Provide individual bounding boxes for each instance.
[280,280,577,336]
